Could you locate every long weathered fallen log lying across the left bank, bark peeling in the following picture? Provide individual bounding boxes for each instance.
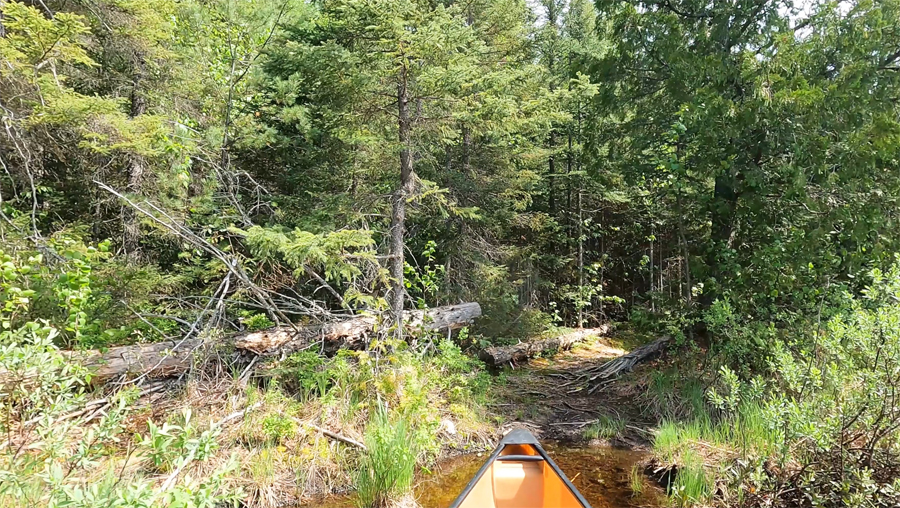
[37,302,481,384]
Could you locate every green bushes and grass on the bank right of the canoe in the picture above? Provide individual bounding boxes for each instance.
[643,265,900,508]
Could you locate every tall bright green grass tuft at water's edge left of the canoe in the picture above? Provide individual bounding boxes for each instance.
[356,408,417,508]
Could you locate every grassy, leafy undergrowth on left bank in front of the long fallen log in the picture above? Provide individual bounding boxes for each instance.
[0,241,493,508]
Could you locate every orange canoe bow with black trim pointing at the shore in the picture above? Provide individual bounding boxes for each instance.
[450,429,591,508]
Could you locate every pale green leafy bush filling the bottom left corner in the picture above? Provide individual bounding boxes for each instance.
[0,248,235,508]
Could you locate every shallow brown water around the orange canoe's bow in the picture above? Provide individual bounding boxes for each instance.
[302,443,666,508]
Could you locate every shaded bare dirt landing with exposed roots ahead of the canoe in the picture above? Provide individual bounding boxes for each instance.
[491,334,656,449]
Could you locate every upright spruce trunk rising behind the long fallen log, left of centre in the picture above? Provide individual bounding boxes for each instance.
[388,62,413,334]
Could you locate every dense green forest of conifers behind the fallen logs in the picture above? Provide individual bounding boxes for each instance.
[0,0,900,506]
